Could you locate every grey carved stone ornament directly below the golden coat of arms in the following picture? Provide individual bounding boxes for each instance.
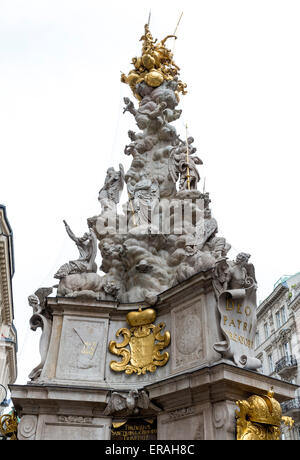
[103,390,150,415]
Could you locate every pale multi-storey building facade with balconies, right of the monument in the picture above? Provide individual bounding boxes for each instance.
[255,273,300,440]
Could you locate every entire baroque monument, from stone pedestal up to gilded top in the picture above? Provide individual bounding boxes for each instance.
[12,25,295,439]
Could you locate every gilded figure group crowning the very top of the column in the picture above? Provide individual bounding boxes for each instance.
[121,24,186,100]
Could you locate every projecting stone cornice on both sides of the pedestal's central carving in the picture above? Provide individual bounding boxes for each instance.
[9,362,298,418]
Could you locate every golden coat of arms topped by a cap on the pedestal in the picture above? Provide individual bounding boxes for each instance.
[108,308,171,375]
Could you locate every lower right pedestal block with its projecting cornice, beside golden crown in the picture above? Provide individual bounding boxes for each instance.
[147,362,296,440]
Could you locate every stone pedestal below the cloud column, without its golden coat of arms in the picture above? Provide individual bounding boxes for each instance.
[11,271,297,440]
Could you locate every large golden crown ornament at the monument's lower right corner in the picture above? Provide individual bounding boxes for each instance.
[236,389,294,441]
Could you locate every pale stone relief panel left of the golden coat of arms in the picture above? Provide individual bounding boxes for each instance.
[56,317,107,381]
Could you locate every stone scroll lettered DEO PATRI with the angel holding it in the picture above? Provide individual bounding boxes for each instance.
[214,253,261,370]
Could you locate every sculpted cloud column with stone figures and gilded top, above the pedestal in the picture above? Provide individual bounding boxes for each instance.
[51,26,255,322]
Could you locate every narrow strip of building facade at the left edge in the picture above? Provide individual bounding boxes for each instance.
[0,205,17,415]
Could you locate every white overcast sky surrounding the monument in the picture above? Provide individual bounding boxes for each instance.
[0,0,300,383]
